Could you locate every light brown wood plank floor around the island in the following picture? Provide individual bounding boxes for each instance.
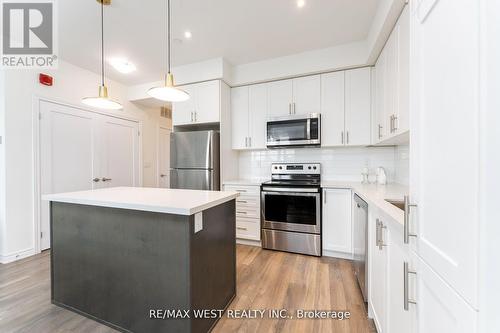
[0,245,376,333]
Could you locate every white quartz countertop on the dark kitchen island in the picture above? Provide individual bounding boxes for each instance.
[43,187,239,215]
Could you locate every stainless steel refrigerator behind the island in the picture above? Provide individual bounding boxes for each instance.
[170,131,220,191]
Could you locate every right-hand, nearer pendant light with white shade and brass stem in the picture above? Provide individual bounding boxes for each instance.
[148,0,189,102]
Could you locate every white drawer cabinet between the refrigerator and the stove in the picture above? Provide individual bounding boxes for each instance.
[224,185,260,241]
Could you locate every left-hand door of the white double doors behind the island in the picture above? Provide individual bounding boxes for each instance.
[40,101,99,250]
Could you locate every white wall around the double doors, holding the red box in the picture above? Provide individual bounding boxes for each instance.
[0,61,162,262]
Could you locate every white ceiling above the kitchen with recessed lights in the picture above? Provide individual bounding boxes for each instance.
[57,0,380,85]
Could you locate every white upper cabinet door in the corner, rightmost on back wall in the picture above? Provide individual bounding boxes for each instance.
[345,67,371,146]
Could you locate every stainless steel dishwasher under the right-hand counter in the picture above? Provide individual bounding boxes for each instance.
[352,194,368,302]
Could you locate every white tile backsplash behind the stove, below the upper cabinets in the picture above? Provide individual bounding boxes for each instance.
[239,147,396,182]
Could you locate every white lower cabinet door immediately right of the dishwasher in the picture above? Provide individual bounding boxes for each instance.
[368,212,388,333]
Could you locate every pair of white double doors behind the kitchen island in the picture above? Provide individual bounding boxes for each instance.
[39,101,141,250]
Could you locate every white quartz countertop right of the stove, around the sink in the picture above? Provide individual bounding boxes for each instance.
[321,181,409,224]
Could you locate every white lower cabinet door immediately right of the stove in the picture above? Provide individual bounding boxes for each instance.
[323,189,352,255]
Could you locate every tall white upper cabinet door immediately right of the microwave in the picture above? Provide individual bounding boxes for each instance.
[321,71,345,146]
